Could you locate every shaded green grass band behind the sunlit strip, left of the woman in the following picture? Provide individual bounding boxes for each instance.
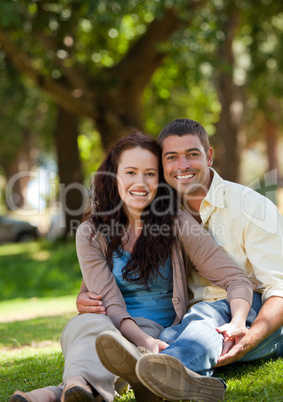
[0,241,82,300]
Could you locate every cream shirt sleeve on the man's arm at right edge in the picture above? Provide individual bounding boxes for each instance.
[244,197,283,303]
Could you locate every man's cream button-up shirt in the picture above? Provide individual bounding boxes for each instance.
[188,169,283,302]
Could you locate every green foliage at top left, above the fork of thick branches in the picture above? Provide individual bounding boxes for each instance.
[0,0,170,79]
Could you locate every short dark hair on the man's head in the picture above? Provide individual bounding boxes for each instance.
[158,119,210,153]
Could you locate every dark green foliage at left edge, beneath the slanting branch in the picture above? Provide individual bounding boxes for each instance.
[0,64,54,167]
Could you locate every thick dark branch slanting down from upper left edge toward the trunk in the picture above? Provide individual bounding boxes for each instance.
[0,29,96,118]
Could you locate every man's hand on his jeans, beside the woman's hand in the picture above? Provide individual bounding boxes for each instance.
[214,327,255,367]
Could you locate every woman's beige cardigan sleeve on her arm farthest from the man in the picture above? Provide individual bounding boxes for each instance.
[76,221,131,329]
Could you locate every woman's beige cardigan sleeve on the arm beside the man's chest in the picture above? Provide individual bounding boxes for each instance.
[178,211,253,304]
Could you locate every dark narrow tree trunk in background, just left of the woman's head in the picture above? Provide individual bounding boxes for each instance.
[55,106,86,237]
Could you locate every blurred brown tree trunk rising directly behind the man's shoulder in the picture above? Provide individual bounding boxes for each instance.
[212,8,243,181]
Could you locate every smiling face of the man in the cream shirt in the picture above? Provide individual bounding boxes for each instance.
[162,134,213,197]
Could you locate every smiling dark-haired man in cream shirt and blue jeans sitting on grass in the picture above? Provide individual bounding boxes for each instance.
[133,119,283,400]
